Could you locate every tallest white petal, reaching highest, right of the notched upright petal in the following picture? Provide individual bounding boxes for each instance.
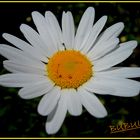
[74,7,95,50]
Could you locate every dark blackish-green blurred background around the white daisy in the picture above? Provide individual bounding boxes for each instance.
[0,3,140,137]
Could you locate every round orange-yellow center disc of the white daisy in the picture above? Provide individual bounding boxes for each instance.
[46,50,92,88]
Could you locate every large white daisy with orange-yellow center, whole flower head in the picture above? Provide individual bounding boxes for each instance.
[0,7,140,134]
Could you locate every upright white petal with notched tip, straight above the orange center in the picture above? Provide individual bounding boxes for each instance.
[62,12,75,49]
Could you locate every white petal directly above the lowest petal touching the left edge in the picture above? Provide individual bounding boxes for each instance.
[3,60,47,75]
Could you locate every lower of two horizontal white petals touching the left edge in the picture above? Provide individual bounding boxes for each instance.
[0,73,46,87]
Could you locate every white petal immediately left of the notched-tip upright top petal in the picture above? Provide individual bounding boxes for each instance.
[45,11,64,50]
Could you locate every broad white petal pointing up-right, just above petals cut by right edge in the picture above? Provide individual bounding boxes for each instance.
[94,41,137,71]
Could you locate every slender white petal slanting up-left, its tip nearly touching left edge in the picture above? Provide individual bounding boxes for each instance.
[3,33,48,62]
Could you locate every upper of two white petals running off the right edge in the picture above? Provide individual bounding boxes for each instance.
[98,67,140,78]
